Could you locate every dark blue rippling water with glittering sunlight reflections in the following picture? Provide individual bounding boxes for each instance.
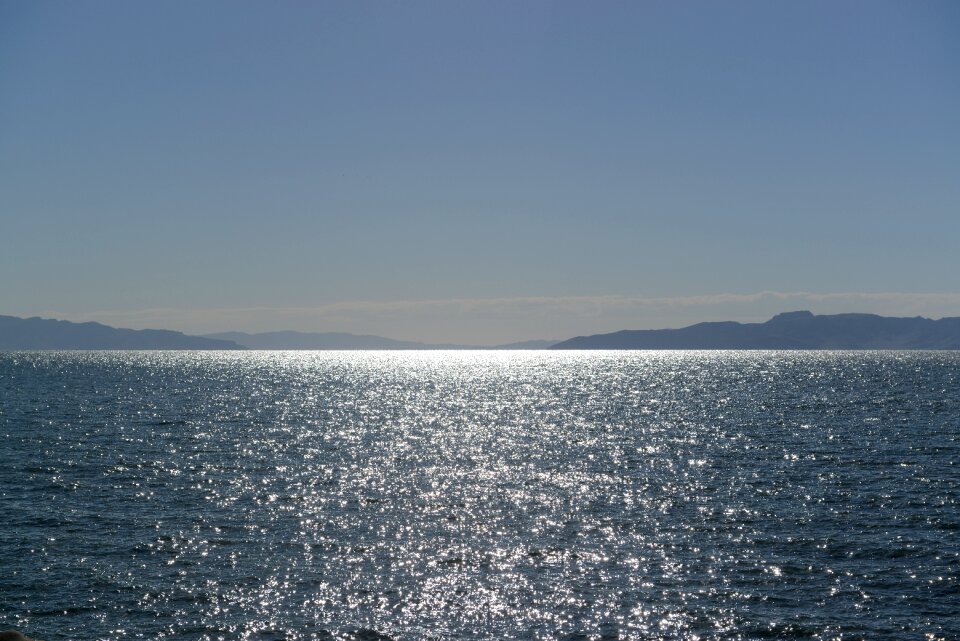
[0,352,960,641]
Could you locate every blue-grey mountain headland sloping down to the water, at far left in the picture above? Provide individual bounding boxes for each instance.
[0,316,242,349]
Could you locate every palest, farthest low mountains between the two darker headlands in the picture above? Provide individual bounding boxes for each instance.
[205,331,557,350]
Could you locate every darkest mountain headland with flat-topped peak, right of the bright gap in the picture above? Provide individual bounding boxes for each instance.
[553,311,960,349]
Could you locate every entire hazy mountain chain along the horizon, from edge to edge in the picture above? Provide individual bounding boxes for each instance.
[7,311,960,350]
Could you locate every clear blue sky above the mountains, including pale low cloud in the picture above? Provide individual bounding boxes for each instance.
[0,0,960,344]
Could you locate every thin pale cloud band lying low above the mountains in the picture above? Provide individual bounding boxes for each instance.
[5,290,960,345]
